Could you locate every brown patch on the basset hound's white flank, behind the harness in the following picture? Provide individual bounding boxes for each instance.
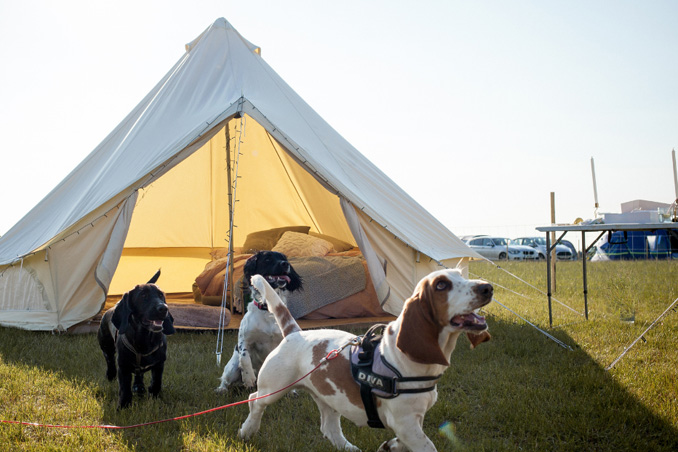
[311,341,363,408]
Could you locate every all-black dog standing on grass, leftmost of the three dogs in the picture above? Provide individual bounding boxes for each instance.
[97,270,174,408]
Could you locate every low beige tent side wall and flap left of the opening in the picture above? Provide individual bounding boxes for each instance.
[0,194,136,331]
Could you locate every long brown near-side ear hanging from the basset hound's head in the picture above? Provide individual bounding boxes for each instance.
[396,281,450,366]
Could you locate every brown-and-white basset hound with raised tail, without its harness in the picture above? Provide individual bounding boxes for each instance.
[239,269,493,452]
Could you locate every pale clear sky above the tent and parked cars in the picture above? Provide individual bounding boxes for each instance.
[0,0,678,244]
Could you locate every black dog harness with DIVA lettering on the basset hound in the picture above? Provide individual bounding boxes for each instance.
[351,323,442,428]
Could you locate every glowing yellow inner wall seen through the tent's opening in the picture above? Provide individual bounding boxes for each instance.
[109,116,355,294]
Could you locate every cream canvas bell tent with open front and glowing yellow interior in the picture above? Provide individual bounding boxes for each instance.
[0,18,479,329]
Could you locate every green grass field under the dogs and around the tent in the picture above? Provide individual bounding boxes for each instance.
[0,261,678,452]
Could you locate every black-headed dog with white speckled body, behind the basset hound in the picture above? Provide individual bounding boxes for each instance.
[217,251,302,392]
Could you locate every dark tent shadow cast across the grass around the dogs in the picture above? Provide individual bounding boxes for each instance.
[0,318,678,451]
